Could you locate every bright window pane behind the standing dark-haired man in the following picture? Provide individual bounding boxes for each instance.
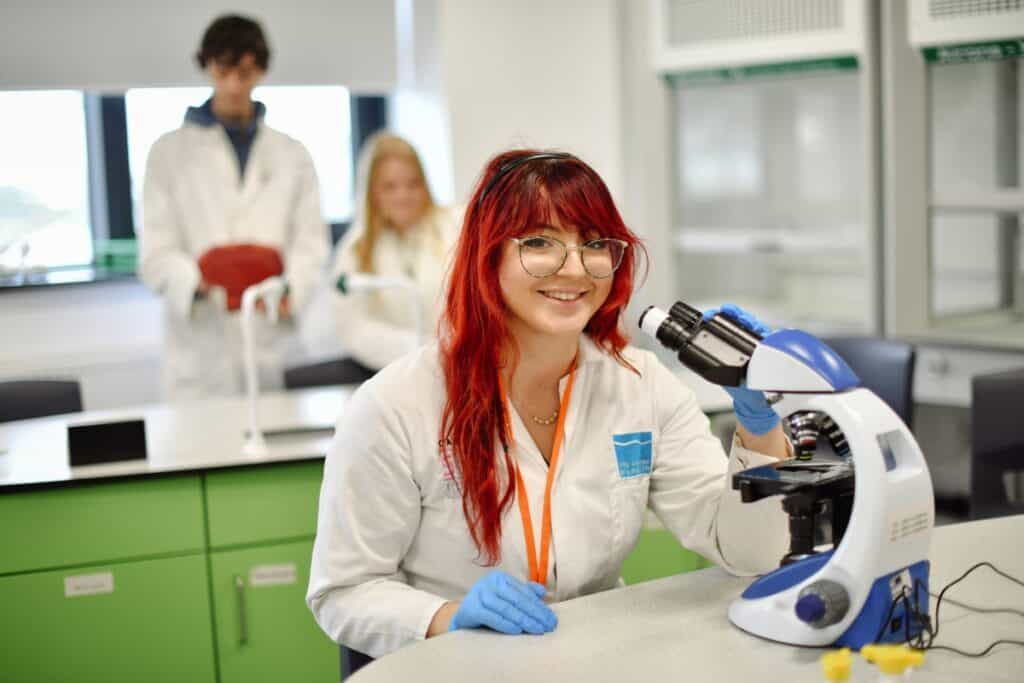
[125,86,352,225]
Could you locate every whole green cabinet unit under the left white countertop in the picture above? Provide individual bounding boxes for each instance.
[0,460,331,683]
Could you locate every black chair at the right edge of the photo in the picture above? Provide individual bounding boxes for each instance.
[971,369,1024,519]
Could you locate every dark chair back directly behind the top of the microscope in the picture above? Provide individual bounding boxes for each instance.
[822,337,914,429]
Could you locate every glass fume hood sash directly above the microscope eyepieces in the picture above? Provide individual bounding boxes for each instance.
[674,69,874,333]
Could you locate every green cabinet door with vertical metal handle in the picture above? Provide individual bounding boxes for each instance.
[210,541,339,683]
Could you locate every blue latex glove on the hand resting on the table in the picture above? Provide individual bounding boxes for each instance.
[449,569,558,636]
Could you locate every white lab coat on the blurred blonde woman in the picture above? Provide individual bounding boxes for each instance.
[333,207,462,370]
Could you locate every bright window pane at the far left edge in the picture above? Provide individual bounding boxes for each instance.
[0,90,92,278]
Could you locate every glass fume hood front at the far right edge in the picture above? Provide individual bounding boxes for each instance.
[929,58,1024,319]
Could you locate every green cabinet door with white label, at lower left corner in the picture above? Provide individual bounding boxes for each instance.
[0,555,216,683]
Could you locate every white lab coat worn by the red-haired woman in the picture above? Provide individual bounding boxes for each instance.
[306,337,788,656]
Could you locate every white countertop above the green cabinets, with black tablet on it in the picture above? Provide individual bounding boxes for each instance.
[0,387,353,490]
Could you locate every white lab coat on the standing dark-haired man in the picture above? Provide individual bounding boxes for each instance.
[139,122,330,399]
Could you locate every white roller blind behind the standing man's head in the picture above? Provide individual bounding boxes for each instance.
[0,0,396,92]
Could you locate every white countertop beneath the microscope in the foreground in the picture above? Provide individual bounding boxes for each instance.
[351,515,1024,683]
